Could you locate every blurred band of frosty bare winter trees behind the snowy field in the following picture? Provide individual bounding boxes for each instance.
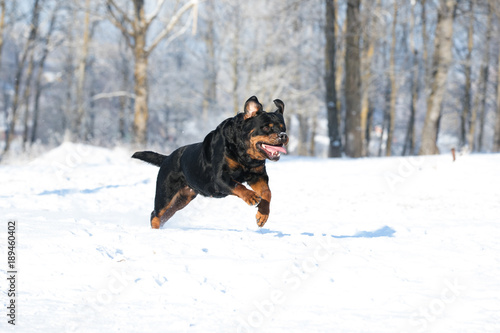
[0,0,500,157]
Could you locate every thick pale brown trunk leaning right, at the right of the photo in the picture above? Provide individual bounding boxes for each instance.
[420,0,456,155]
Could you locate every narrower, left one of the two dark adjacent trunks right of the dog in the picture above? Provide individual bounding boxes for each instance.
[325,0,342,157]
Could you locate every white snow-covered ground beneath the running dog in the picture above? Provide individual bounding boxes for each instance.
[0,144,500,333]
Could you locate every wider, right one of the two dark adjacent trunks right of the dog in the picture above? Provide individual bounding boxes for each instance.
[345,0,363,157]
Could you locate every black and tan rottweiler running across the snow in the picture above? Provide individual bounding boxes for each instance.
[132,96,288,229]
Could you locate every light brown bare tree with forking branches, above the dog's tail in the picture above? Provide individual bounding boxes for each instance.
[106,0,198,145]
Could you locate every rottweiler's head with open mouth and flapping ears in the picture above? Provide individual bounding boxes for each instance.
[242,96,288,161]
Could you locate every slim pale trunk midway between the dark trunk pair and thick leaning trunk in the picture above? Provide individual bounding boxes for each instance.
[385,1,398,156]
